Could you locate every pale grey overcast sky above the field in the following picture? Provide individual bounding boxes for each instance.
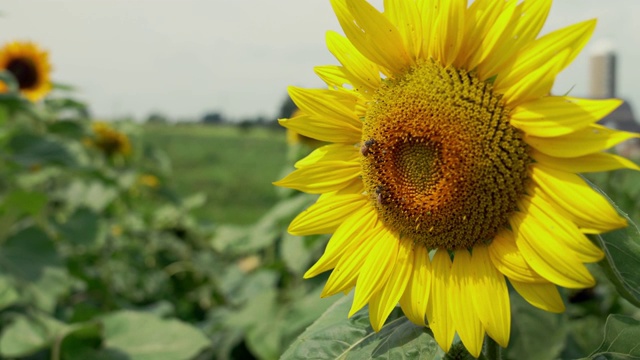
[0,0,640,120]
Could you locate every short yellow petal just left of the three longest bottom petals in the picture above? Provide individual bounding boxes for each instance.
[400,244,432,326]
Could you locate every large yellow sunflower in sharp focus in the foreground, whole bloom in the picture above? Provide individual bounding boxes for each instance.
[275,0,638,356]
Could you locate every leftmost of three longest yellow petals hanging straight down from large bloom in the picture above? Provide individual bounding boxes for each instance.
[426,250,456,352]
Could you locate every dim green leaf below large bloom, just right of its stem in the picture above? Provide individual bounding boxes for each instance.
[505,292,569,360]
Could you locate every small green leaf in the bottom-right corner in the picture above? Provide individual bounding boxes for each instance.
[587,314,640,360]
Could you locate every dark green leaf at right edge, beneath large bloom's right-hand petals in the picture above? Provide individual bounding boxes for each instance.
[591,209,640,307]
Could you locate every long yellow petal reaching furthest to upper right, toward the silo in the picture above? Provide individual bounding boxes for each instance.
[494,20,596,92]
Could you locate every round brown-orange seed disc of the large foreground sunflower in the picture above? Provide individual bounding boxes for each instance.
[362,61,531,250]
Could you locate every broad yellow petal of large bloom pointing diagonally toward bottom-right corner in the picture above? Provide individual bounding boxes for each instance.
[510,213,595,289]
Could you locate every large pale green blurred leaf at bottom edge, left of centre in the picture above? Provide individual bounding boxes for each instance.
[102,311,209,360]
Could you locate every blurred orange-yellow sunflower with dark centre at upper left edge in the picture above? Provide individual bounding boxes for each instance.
[0,41,51,101]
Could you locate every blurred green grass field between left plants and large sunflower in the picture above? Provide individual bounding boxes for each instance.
[143,125,287,225]
